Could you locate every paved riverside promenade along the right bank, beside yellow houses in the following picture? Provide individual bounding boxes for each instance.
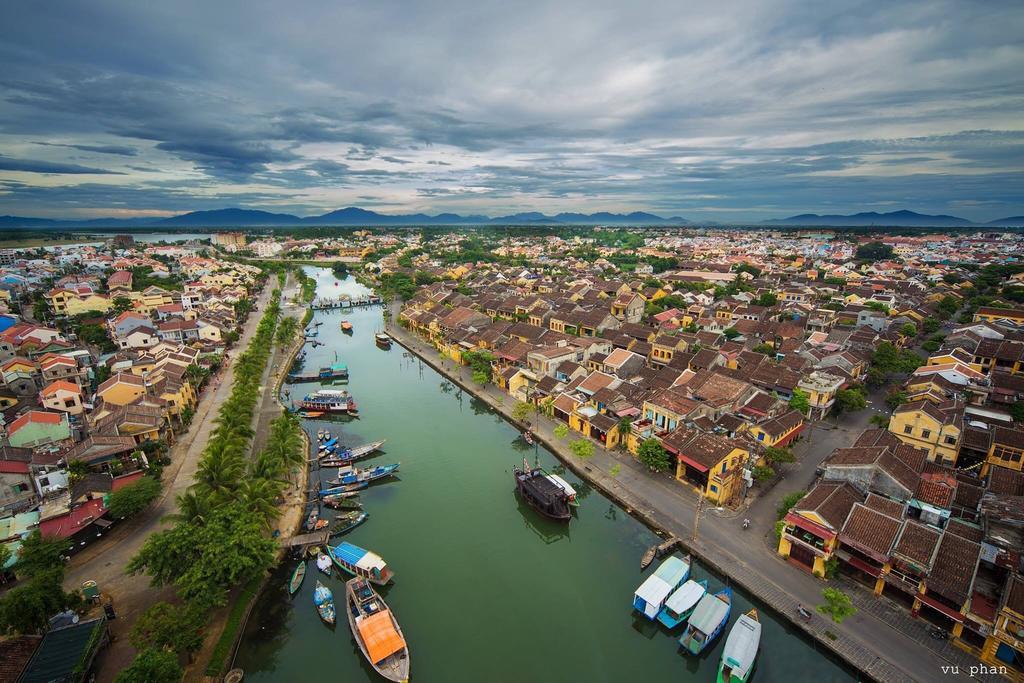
[387,309,1001,682]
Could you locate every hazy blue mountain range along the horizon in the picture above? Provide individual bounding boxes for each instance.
[0,207,1024,229]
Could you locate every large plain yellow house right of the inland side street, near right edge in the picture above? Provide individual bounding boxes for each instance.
[889,399,964,467]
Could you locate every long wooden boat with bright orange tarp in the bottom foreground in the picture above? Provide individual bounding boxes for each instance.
[345,579,410,683]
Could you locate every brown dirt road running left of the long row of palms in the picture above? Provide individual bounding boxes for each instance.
[65,282,274,683]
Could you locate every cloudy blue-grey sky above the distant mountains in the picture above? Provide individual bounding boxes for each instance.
[0,0,1024,222]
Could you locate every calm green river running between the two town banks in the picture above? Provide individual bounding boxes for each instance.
[236,268,856,683]
